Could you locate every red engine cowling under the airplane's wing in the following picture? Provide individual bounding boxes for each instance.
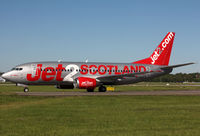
[76,77,97,89]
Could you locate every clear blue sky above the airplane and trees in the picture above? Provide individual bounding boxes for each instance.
[0,0,200,73]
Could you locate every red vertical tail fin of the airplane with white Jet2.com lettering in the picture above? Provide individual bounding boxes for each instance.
[133,32,175,65]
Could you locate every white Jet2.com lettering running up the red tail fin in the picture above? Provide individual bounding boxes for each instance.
[150,32,174,64]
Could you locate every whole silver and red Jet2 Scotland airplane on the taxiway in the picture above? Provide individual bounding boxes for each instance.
[2,32,193,92]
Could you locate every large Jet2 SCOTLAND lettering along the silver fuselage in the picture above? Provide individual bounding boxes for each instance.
[26,64,147,81]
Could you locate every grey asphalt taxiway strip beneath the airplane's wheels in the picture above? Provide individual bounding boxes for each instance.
[16,90,200,97]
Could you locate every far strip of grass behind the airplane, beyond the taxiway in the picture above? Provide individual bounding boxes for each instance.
[0,82,200,94]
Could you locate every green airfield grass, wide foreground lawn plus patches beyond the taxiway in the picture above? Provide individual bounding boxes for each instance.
[0,85,200,136]
